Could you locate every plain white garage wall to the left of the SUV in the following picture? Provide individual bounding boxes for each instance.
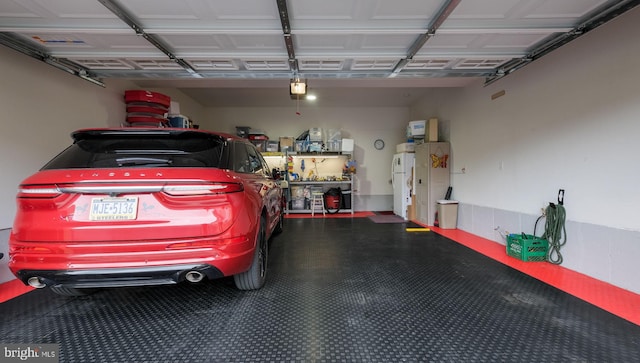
[0,47,139,283]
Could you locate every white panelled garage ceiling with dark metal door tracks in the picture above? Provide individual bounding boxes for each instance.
[0,0,639,106]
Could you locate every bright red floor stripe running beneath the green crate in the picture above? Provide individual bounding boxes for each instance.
[431,227,640,325]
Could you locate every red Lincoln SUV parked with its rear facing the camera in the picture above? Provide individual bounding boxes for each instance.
[9,128,285,296]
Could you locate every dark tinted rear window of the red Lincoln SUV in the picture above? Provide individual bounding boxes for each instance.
[42,132,225,170]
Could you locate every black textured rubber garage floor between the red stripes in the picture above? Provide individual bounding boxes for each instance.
[0,218,640,362]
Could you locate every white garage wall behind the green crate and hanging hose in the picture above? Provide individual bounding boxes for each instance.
[412,9,640,292]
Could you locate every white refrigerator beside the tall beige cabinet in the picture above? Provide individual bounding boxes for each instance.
[391,153,415,219]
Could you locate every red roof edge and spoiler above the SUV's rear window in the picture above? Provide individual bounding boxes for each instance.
[71,127,249,143]
